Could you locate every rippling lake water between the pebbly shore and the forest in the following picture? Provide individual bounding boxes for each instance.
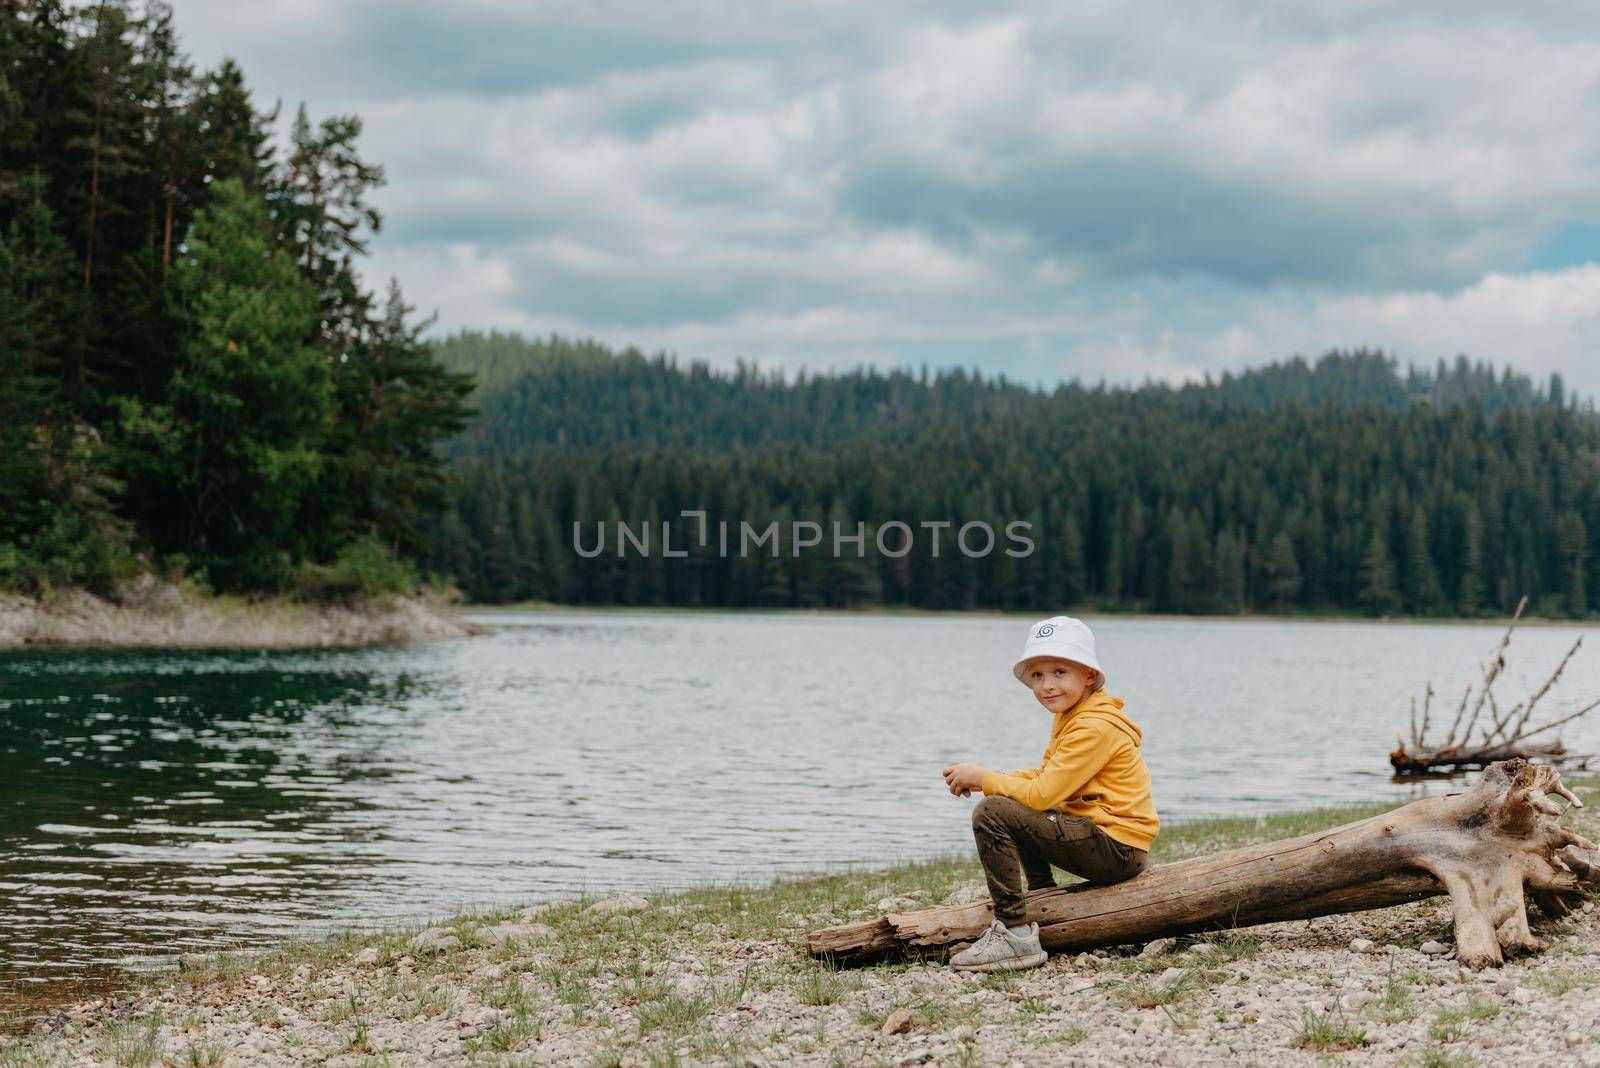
[0,612,1600,1017]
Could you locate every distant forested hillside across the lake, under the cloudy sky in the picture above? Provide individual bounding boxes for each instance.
[429,334,1600,616]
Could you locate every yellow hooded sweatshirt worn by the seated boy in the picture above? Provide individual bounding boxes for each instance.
[984,689,1160,849]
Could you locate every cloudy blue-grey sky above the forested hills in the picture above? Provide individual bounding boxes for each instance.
[176,0,1600,393]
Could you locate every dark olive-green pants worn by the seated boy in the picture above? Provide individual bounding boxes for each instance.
[973,798,1149,927]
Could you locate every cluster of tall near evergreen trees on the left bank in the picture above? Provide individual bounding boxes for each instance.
[0,0,470,592]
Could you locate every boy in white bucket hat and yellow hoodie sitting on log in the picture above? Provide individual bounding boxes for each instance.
[944,616,1160,972]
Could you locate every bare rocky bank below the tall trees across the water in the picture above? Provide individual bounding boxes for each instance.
[0,582,488,649]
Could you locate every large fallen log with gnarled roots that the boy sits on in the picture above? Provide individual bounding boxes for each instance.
[808,759,1600,969]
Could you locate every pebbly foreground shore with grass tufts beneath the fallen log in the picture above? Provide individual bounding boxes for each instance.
[0,782,1600,1068]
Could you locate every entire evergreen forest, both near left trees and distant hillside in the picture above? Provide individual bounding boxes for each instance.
[0,0,1600,617]
